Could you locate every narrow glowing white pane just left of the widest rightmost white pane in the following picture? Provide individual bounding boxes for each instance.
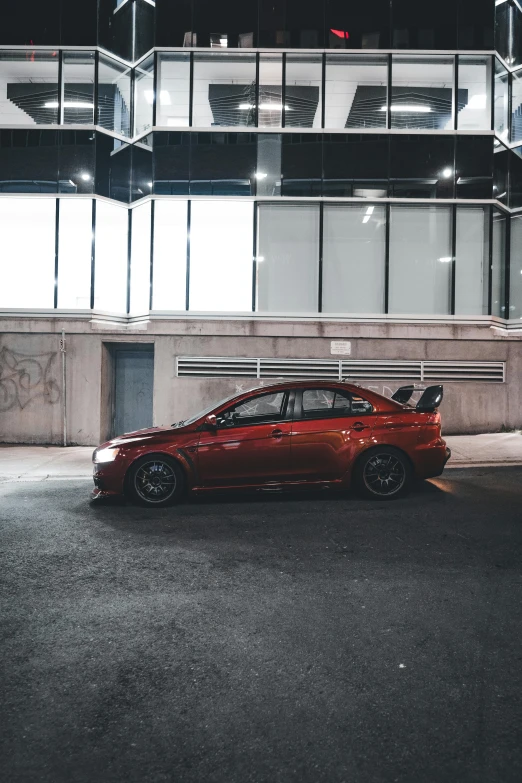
[152,201,187,310]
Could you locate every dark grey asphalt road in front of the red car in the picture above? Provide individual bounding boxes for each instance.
[0,468,522,783]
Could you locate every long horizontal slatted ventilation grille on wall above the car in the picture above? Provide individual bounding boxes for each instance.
[177,356,506,383]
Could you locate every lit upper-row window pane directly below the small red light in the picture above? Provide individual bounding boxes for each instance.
[325,54,388,128]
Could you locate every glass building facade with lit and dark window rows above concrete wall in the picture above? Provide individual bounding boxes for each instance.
[0,0,522,319]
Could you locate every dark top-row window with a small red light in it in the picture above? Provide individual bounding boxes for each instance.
[325,0,390,49]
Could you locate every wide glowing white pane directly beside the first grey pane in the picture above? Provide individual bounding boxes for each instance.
[190,201,254,312]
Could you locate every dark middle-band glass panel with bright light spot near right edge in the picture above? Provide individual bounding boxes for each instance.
[390,135,454,198]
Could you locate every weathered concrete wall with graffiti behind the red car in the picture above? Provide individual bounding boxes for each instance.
[0,317,522,445]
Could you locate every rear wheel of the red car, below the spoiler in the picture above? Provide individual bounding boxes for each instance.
[353,446,413,500]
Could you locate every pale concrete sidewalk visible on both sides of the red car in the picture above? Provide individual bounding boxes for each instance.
[0,432,522,482]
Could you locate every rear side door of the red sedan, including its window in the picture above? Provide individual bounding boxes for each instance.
[291,387,376,482]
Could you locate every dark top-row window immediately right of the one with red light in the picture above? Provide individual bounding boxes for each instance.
[392,0,457,49]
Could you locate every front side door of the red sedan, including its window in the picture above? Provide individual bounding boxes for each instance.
[197,390,294,487]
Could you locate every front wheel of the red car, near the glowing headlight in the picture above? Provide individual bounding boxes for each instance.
[125,454,185,508]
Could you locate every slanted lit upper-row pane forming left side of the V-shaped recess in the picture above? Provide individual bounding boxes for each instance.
[98,54,130,136]
